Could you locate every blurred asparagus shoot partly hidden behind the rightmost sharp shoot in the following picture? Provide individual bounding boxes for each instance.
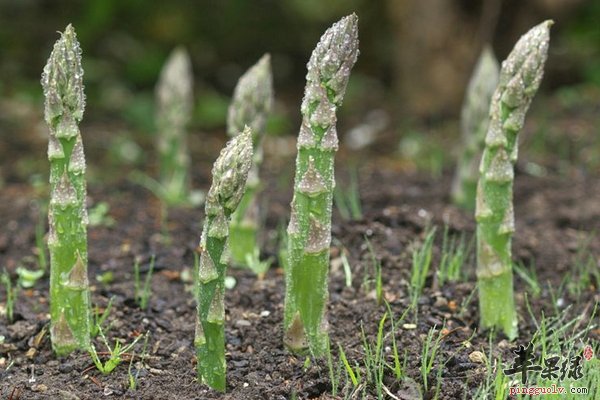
[451,46,500,210]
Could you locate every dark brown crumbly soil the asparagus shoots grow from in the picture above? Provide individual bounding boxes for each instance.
[0,130,600,400]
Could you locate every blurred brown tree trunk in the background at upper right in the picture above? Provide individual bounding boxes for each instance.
[388,0,481,117]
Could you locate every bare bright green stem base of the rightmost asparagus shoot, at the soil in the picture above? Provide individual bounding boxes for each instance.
[478,269,518,340]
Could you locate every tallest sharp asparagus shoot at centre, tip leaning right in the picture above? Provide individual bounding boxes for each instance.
[284,14,358,356]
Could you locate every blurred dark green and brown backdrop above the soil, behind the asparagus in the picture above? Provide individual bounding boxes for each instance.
[0,0,600,180]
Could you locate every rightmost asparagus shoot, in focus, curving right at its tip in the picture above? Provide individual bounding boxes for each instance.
[475,21,552,339]
